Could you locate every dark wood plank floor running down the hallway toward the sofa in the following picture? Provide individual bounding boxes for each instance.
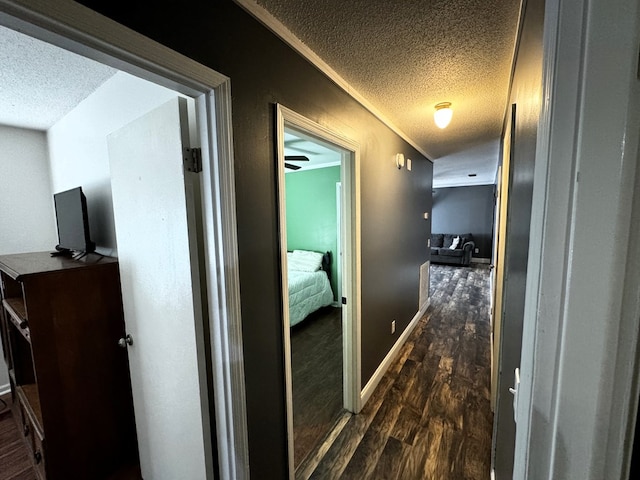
[310,265,493,480]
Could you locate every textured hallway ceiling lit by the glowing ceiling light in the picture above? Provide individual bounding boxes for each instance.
[248,0,520,183]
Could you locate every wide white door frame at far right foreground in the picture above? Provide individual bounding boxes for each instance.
[513,0,640,480]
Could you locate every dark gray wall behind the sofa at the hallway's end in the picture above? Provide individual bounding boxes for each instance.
[431,185,495,259]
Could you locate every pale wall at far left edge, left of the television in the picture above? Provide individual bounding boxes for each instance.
[0,126,58,394]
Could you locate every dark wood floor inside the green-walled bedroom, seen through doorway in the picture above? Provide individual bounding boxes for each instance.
[290,307,343,467]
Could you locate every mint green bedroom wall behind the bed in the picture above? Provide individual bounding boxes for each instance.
[285,166,340,300]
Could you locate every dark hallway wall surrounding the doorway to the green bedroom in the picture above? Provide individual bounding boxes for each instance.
[80,0,433,479]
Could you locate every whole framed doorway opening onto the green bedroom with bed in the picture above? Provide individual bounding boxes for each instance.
[277,105,361,478]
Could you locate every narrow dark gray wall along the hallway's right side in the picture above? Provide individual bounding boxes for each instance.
[494,0,544,480]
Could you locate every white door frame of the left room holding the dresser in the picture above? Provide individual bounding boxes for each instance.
[0,0,249,479]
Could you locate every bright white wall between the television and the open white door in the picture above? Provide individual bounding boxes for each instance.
[47,72,190,255]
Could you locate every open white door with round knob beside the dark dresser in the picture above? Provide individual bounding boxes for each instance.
[108,98,210,480]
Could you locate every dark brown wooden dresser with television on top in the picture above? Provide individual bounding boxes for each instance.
[0,252,138,480]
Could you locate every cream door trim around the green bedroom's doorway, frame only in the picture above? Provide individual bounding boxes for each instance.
[276,104,362,479]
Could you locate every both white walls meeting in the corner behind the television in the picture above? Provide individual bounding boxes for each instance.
[0,72,188,394]
